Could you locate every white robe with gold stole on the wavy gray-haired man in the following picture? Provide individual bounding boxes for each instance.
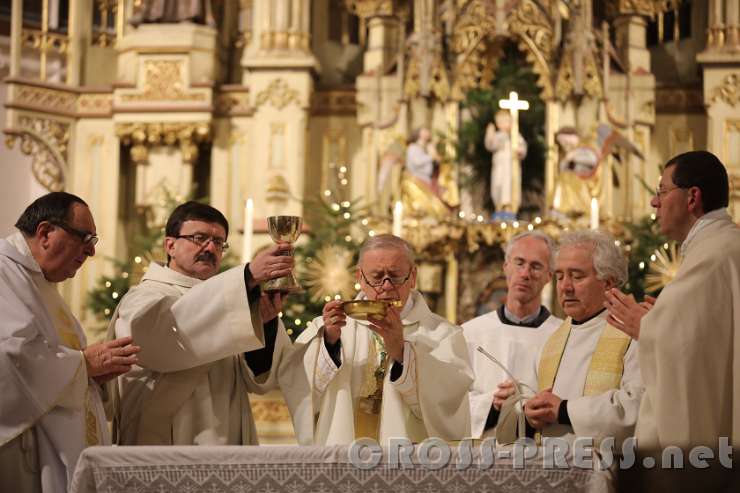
[537,311,644,446]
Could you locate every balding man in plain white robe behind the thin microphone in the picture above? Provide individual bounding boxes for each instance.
[462,231,562,441]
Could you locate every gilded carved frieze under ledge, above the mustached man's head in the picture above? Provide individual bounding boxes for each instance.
[116,122,211,164]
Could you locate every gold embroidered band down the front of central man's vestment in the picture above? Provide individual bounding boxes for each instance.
[354,332,388,440]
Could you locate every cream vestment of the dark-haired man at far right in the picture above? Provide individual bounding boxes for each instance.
[636,209,740,453]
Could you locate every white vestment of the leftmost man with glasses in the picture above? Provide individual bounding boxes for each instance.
[0,232,110,492]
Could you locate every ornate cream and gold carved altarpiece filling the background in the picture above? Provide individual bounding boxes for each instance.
[5,0,740,319]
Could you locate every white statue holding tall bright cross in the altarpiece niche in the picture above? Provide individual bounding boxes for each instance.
[485,92,529,220]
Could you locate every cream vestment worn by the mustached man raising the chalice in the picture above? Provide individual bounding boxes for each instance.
[108,263,308,445]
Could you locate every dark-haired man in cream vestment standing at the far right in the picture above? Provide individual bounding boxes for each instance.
[610,151,740,491]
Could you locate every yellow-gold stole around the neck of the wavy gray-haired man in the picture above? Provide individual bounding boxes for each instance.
[537,317,632,396]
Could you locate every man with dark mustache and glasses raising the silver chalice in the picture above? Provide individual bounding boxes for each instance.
[109,202,308,445]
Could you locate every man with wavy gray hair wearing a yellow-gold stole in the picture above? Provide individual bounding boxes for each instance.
[524,230,644,446]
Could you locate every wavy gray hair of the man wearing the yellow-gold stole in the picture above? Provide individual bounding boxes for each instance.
[558,229,627,287]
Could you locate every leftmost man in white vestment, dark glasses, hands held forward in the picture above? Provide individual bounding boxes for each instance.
[0,192,138,492]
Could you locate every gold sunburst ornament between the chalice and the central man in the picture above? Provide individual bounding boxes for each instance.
[305,245,355,303]
